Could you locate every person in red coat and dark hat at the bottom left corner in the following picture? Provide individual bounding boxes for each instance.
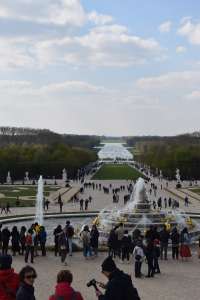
[0,255,19,300]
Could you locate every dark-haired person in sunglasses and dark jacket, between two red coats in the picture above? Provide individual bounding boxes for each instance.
[16,266,37,300]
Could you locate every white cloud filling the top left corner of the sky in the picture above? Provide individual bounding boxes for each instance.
[0,0,87,26]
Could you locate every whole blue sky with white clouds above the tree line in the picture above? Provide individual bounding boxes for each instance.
[0,0,200,136]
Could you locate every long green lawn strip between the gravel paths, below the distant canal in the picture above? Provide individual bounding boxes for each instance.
[92,164,144,180]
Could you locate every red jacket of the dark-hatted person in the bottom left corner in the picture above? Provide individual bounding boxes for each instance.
[0,269,19,300]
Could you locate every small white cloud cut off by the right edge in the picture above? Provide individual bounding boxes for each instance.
[177,19,200,45]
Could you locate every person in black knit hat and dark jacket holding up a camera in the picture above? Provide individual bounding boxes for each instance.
[96,256,140,300]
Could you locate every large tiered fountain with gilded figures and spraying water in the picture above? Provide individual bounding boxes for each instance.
[93,178,200,239]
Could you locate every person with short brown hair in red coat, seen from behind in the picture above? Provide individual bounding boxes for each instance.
[49,270,83,300]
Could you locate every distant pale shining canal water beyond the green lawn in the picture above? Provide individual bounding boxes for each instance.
[98,143,133,160]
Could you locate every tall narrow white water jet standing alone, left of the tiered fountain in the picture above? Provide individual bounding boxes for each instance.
[35,175,44,225]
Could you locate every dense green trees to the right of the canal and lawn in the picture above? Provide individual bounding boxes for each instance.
[134,138,200,180]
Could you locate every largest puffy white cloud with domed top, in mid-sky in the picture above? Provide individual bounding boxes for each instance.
[33,24,162,67]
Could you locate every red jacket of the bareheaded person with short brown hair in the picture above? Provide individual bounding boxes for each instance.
[49,282,83,300]
